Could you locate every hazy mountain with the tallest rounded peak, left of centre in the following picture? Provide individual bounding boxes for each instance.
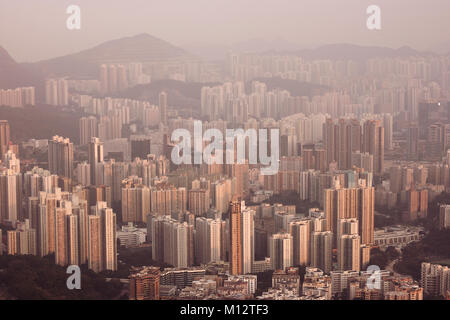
[36,33,195,76]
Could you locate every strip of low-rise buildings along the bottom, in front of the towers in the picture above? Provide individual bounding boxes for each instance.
[129,267,424,300]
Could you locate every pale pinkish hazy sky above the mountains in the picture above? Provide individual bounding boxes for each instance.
[0,0,450,62]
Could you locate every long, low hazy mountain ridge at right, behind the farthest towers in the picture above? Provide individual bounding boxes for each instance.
[295,43,434,61]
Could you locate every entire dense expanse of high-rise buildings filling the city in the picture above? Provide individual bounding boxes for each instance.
[0,46,450,300]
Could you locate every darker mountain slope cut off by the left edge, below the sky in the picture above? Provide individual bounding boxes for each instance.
[0,47,42,89]
